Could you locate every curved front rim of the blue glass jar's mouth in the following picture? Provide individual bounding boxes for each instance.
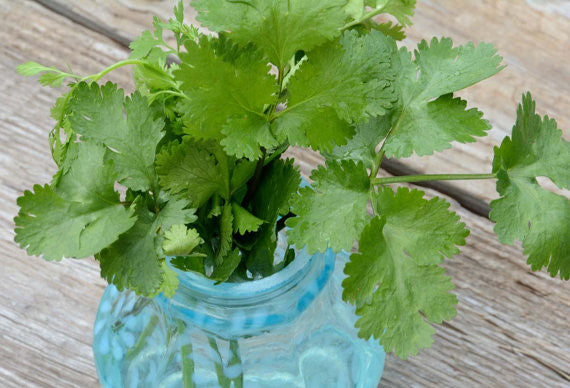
[169,249,328,303]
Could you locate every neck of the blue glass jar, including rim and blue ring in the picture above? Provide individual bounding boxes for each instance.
[157,250,335,338]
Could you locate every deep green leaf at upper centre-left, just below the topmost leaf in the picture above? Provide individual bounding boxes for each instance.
[174,35,278,151]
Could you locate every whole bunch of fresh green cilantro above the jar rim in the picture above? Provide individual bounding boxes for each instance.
[15,0,570,358]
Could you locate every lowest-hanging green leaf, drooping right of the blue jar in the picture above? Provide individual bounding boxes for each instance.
[351,217,457,359]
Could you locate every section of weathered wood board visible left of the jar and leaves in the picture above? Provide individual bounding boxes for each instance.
[0,0,132,387]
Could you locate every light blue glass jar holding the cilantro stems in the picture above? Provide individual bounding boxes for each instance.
[93,236,385,388]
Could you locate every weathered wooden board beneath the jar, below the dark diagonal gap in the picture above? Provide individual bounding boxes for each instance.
[0,0,570,387]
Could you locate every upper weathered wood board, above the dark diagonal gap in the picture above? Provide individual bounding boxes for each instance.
[31,0,570,209]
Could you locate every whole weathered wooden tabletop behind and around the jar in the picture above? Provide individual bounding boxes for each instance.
[0,0,570,387]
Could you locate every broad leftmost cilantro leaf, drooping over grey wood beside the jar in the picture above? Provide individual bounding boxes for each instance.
[14,143,135,260]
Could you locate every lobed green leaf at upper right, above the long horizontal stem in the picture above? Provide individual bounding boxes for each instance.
[384,38,503,158]
